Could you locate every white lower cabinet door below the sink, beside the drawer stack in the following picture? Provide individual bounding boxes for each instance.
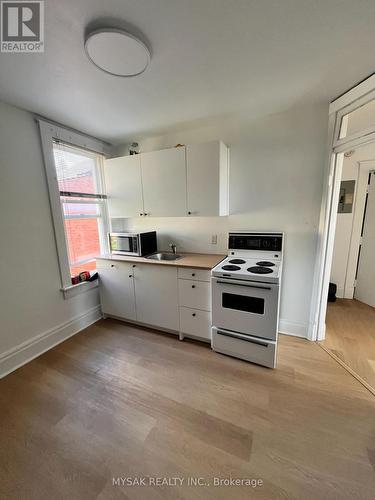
[134,264,179,331]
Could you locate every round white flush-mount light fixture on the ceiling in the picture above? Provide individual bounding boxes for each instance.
[85,28,151,77]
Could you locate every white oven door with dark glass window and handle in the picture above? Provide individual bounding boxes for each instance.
[212,278,279,340]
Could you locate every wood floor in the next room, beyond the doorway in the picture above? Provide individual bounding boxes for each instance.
[321,299,375,394]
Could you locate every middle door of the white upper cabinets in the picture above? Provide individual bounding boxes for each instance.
[141,147,187,217]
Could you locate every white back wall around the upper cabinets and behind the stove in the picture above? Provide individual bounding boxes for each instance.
[114,105,328,336]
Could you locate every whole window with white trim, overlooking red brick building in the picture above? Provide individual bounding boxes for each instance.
[37,118,111,298]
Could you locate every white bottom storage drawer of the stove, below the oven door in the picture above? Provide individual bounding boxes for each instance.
[212,327,276,368]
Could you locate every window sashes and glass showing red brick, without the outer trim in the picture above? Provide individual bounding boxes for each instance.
[53,140,105,277]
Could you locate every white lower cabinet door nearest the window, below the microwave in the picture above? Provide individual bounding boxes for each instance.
[97,261,136,321]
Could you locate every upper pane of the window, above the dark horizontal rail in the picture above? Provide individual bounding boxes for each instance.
[53,144,101,194]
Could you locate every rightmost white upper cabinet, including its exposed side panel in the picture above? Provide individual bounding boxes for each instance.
[186,141,229,217]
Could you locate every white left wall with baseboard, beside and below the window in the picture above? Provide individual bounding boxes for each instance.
[0,103,99,376]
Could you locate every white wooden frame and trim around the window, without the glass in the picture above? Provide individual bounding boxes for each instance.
[36,117,111,298]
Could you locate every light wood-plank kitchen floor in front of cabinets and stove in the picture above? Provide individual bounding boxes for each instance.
[0,320,375,500]
